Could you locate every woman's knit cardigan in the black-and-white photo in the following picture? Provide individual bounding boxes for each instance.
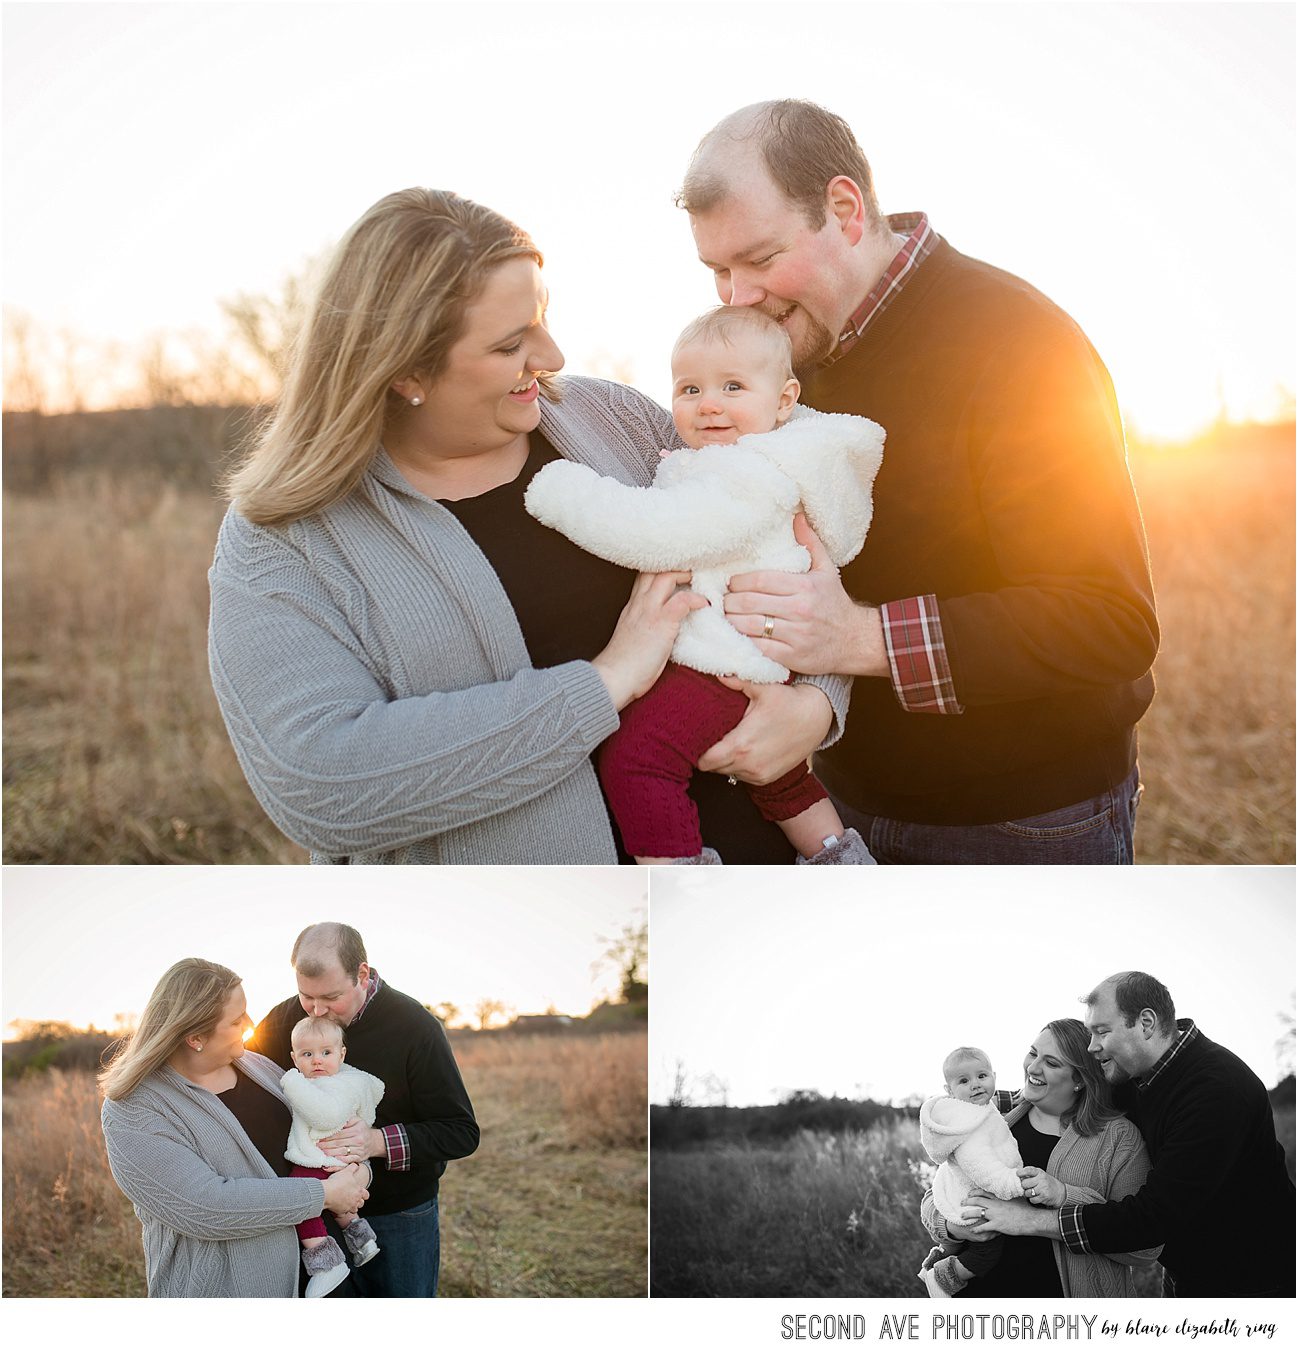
[919,1103,1163,1301]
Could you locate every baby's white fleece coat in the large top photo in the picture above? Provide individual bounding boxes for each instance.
[525,407,884,683]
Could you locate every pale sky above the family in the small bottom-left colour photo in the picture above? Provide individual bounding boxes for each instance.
[4,867,646,1028]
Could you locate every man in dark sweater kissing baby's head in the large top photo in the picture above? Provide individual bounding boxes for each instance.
[677,100,1157,864]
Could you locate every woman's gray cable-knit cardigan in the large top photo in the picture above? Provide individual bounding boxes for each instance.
[210,377,849,864]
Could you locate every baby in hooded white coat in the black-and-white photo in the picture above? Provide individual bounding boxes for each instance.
[918,1046,1024,1299]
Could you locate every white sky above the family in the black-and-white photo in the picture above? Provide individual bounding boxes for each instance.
[649,868,1294,1105]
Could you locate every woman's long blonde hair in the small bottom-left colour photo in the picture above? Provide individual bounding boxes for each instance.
[99,957,242,1099]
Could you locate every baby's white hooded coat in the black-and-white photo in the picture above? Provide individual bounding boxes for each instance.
[919,1094,1024,1225]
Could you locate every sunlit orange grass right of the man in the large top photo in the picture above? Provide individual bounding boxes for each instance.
[1132,431,1294,864]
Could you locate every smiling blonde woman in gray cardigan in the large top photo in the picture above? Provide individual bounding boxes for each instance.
[210,188,845,864]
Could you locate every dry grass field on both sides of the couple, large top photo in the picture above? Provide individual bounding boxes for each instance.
[4,429,1294,864]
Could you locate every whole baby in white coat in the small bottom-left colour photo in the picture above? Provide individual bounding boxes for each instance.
[280,1018,383,1297]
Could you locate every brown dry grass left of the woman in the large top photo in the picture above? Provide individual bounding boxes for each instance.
[4,477,306,864]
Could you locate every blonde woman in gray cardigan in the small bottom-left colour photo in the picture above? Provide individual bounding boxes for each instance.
[100,957,369,1297]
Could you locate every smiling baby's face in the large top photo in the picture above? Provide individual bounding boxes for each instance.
[672,337,798,450]
